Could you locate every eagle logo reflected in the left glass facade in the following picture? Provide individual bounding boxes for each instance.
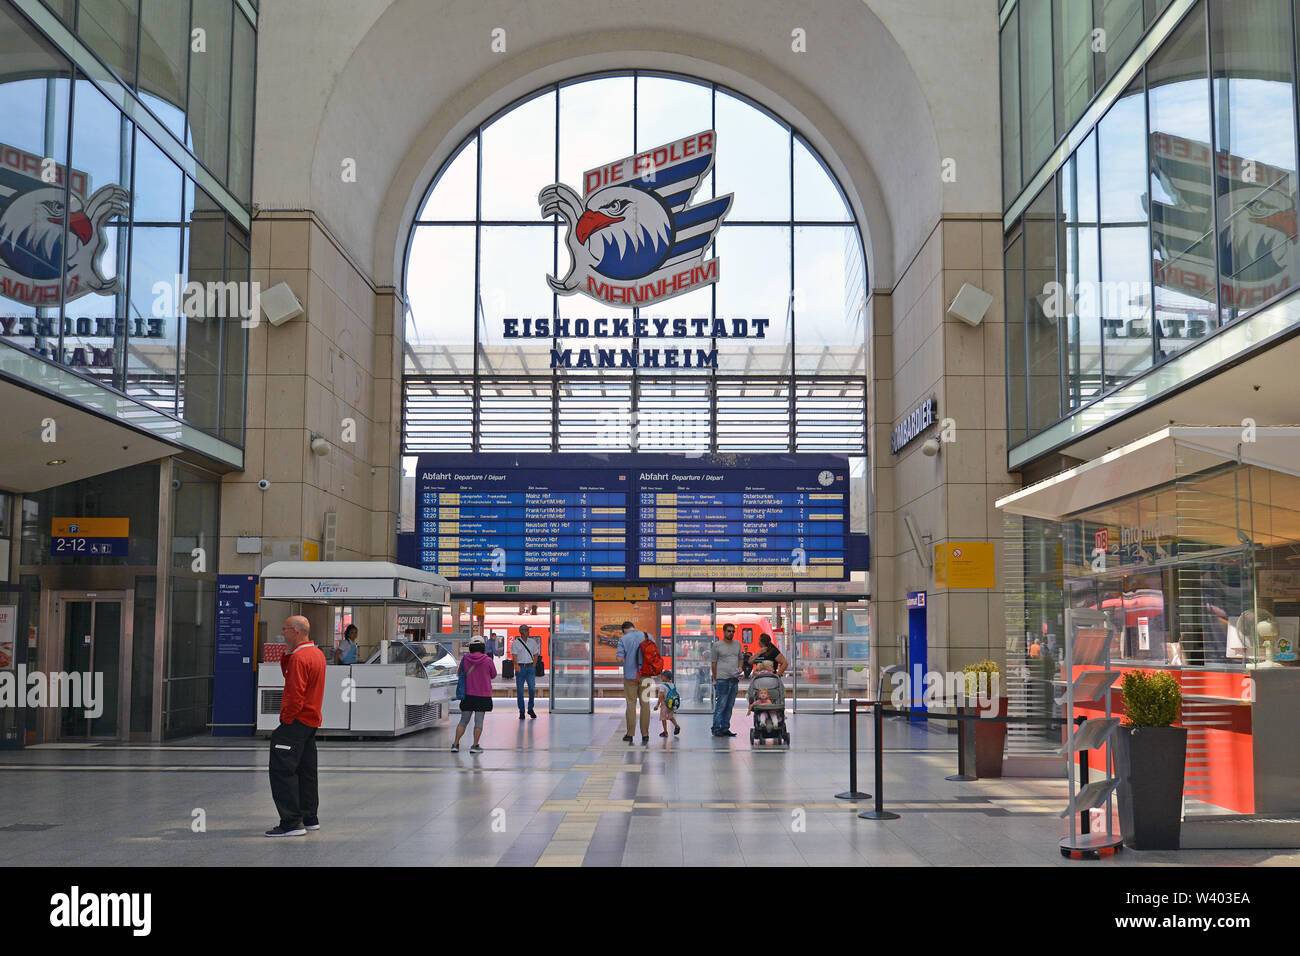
[0,144,130,306]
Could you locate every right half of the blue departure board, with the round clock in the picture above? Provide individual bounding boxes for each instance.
[636,463,849,580]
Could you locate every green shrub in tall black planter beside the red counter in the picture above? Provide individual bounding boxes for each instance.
[1115,671,1187,849]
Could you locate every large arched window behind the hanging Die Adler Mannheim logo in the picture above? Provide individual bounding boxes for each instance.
[403,72,867,454]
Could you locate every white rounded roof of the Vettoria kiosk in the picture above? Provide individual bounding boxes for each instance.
[261,561,451,605]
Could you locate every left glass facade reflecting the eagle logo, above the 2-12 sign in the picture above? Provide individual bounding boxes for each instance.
[0,0,256,445]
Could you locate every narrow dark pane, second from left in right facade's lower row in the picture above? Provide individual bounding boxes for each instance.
[1024,181,1061,434]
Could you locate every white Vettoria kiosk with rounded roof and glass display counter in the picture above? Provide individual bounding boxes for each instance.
[257,561,458,736]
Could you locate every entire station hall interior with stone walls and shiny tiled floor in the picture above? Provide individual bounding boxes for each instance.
[0,0,1300,868]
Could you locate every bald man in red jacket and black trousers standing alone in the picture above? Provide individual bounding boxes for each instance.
[267,615,325,836]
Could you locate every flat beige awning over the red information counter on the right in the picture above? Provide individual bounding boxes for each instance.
[997,425,1300,520]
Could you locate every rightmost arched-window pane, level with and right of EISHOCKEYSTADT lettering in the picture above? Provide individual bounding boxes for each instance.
[790,226,867,375]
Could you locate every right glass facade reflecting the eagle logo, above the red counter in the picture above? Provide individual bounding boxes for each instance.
[1002,0,1300,449]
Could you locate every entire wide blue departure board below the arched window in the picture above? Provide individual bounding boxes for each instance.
[415,454,849,581]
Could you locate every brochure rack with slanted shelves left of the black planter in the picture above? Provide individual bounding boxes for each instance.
[1057,607,1123,860]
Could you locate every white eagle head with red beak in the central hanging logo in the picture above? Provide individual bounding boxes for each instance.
[575,186,672,278]
